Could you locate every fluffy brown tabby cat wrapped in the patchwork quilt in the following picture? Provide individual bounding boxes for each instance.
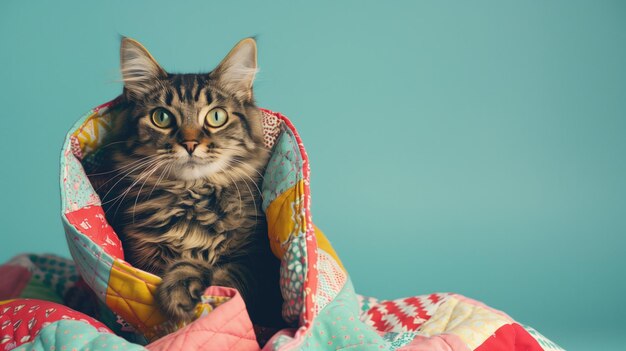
[91,38,282,332]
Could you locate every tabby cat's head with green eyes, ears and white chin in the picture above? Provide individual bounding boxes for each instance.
[120,38,265,181]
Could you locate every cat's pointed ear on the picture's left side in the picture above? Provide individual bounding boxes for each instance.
[120,37,167,98]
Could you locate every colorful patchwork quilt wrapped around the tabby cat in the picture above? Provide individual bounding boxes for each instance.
[0,100,562,351]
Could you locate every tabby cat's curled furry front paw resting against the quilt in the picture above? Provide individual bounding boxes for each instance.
[155,261,212,323]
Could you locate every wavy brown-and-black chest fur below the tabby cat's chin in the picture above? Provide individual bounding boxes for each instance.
[113,182,256,273]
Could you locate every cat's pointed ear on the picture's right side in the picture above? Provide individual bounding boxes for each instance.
[211,38,257,101]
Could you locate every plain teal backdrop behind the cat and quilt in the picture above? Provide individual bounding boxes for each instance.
[0,1,626,350]
